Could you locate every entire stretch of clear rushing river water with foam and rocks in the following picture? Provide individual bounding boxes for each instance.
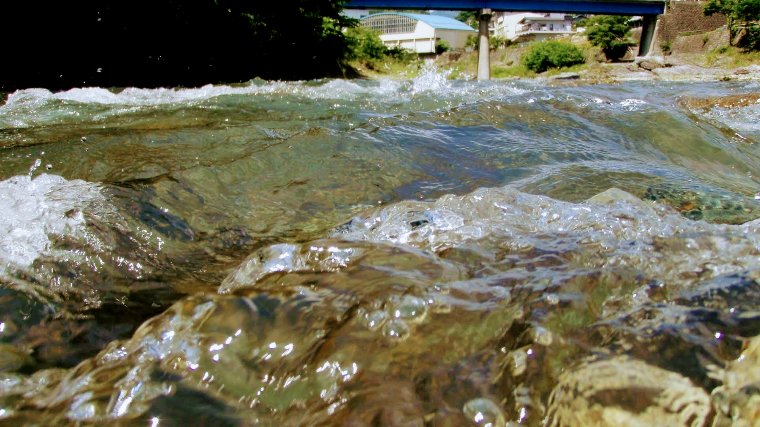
[0,69,760,426]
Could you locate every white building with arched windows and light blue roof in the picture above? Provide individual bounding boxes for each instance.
[360,12,478,53]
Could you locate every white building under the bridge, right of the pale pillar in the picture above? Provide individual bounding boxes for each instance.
[492,12,575,41]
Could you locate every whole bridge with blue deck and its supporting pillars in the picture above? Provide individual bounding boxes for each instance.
[345,0,665,80]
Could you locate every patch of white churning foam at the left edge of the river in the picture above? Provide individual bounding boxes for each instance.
[0,174,102,274]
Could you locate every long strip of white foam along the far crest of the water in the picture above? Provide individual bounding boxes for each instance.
[0,71,527,128]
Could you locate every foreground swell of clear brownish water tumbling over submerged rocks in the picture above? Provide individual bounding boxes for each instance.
[0,187,760,425]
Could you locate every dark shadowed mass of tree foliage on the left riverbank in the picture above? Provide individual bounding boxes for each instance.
[0,0,355,91]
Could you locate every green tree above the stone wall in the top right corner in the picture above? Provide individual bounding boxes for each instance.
[704,0,760,50]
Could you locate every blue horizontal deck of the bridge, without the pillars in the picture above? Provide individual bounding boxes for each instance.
[345,0,665,15]
